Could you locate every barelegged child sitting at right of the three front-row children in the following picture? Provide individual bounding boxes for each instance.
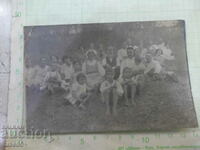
[119,67,136,106]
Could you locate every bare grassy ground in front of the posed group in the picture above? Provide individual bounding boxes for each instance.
[27,74,197,134]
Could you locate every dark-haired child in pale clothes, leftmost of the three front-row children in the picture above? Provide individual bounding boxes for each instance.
[66,73,90,109]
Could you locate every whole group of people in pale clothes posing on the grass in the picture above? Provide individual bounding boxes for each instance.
[25,38,177,115]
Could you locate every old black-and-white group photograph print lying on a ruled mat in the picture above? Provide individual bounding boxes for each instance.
[24,20,198,134]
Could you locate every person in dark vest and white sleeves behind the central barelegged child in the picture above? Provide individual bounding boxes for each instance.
[102,46,120,80]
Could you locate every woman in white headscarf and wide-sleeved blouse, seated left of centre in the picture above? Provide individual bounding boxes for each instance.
[82,49,105,89]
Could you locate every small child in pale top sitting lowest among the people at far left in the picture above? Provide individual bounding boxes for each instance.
[40,65,63,94]
